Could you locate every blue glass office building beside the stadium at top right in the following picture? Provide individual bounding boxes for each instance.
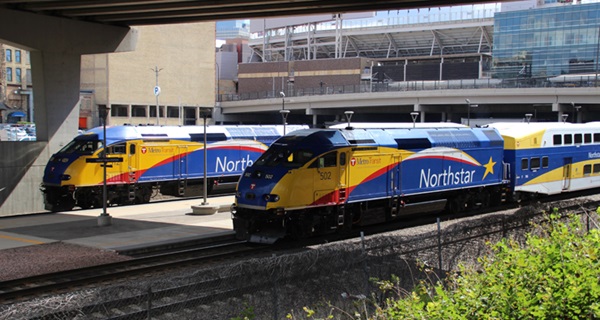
[492,3,600,79]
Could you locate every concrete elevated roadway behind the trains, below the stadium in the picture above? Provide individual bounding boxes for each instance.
[219,86,600,125]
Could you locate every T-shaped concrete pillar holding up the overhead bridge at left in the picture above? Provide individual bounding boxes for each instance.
[0,8,137,216]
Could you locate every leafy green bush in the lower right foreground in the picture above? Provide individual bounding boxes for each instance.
[384,208,600,320]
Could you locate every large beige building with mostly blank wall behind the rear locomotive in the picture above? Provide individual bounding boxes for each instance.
[79,22,215,128]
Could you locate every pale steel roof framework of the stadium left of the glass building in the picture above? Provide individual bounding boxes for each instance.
[248,18,494,62]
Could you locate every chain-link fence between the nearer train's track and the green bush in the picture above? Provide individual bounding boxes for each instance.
[0,207,598,320]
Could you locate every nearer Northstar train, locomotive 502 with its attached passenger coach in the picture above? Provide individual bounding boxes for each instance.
[233,123,600,243]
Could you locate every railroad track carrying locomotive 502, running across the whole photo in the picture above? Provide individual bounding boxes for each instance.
[5,188,599,304]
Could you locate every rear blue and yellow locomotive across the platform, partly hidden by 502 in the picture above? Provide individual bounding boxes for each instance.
[41,125,307,211]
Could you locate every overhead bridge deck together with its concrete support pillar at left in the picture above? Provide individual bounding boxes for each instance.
[0,0,524,216]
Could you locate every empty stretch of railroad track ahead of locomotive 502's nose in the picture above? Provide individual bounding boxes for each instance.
[0,240,256,304]
